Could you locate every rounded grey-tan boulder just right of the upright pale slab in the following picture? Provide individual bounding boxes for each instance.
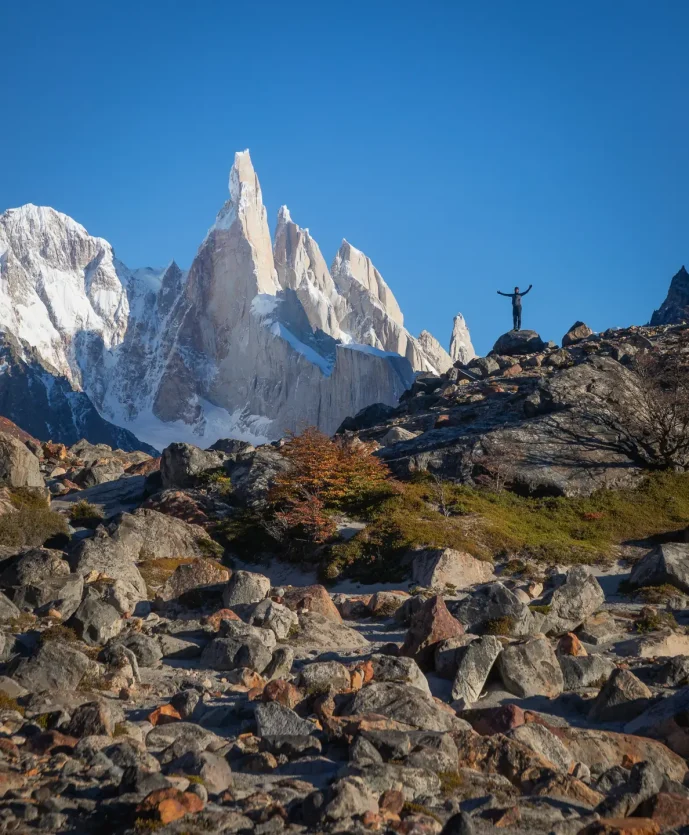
[498,636,564,699]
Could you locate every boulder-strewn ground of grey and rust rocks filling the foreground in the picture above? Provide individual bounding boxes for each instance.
[0,428,689,835]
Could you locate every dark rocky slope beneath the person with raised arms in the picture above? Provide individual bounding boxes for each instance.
[341,323,687,496]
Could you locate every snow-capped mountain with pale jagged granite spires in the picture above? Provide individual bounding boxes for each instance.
[0,151,473,448]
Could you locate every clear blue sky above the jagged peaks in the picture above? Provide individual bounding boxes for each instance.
[0,0,689,352]
